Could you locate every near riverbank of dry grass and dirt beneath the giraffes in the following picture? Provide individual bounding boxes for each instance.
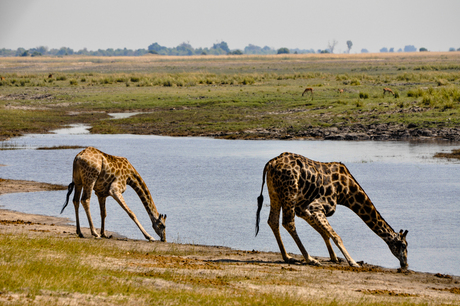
[0,181,460,305]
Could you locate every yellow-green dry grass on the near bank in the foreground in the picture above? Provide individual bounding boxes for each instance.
[0,234,432,305]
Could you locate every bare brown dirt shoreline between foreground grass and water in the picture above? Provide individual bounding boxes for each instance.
[0,180,460,305]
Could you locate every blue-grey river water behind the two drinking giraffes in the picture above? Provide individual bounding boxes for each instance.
[0,130,460,275]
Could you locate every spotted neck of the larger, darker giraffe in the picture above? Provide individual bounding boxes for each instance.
[341,184,397,244]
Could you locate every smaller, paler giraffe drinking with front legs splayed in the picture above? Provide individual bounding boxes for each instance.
[61,147,166,242]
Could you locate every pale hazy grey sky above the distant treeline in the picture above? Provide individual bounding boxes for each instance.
[0,0,460,53]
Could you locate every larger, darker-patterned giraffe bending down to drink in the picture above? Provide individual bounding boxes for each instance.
[256,152,409,270]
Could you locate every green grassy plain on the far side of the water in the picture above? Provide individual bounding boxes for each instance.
[0,52,460,138]
